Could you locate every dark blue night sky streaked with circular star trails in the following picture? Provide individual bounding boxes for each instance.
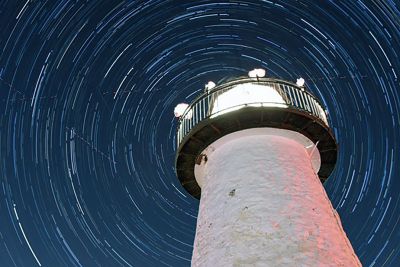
[0,0,400,267]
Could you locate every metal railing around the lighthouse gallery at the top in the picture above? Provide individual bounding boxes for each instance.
[177,78,329,147]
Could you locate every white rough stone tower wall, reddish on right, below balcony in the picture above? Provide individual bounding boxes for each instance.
[192,129,361,267]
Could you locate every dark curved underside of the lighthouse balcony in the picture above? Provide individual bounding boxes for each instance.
[176,106,337,198]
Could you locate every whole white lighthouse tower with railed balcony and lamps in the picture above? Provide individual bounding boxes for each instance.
[175,69,361,266]
